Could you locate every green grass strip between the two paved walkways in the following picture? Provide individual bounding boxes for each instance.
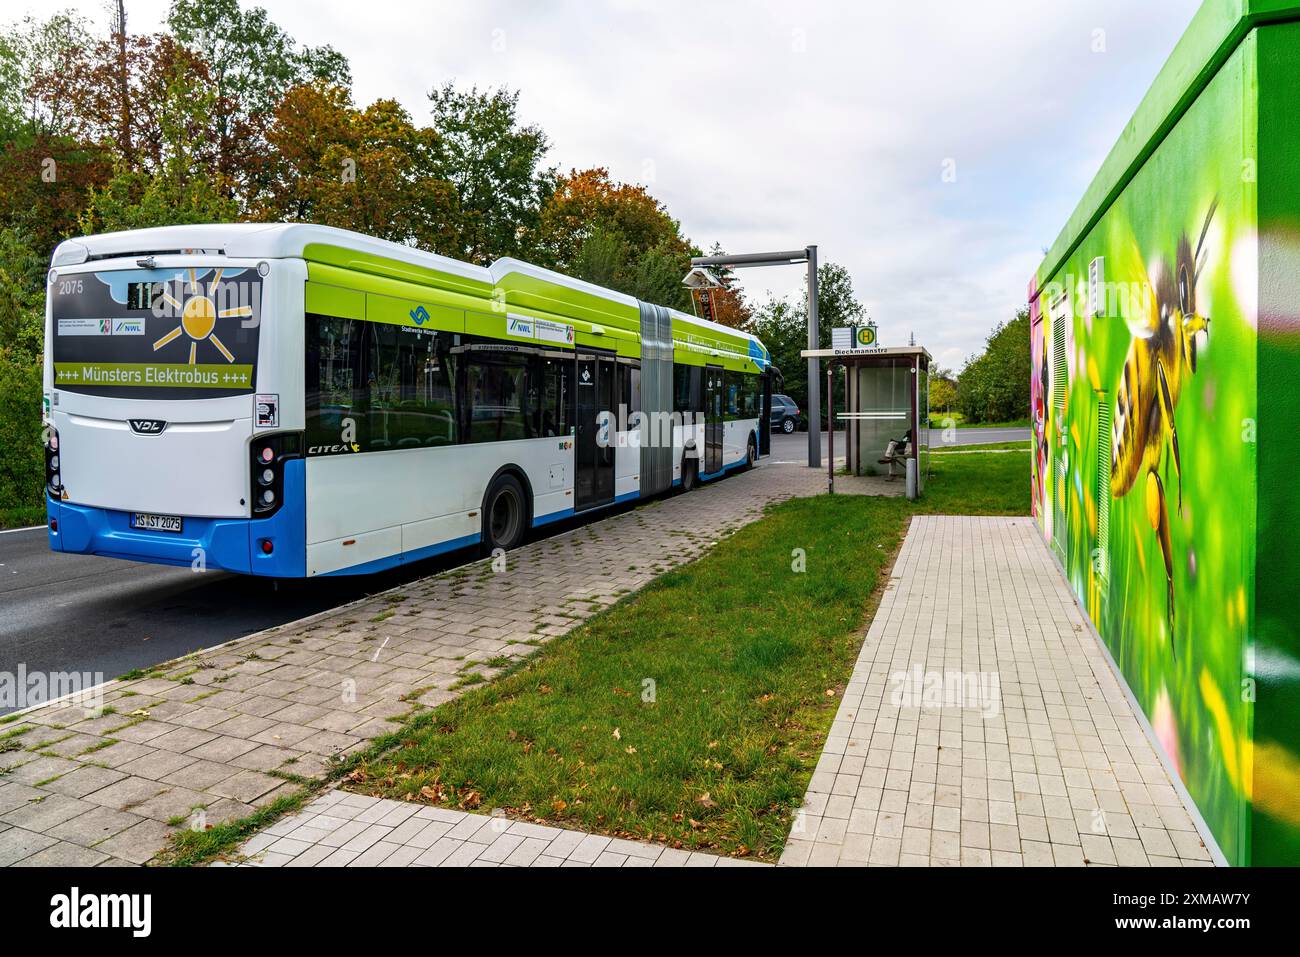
[351,455,1030,859]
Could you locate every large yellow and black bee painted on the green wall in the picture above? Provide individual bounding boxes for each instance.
[1110,200,1218,628]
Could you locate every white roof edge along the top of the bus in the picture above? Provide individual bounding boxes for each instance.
[51,222,762,345]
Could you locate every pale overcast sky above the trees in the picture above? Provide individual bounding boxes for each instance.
[32,0,1199,367]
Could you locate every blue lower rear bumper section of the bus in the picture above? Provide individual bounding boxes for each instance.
[46,459,307,579]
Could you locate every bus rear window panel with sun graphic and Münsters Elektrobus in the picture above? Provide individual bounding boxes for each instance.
[49,267,261,399]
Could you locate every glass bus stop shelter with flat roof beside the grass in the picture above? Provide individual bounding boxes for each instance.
[802,346,931,498]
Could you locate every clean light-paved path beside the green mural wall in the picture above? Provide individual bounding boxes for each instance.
[781,516,1210,866]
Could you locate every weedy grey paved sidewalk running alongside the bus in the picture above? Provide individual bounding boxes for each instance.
[0,463,832,866]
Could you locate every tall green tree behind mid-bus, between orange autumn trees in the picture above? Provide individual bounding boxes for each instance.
[429,83,555,263]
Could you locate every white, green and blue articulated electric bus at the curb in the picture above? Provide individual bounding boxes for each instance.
[44,224,774,577]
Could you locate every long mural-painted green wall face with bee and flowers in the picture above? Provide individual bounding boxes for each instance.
[1034,22,1260,863]
